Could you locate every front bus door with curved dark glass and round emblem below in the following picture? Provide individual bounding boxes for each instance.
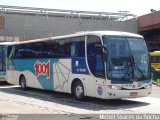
[87,36,106,98]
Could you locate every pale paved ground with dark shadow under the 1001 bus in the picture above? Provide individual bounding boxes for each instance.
[0,84,160,120]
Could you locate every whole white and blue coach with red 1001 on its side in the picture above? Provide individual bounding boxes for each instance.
[7,31,152,100]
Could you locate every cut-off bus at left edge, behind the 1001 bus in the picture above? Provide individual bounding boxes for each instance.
[0,45,7,82]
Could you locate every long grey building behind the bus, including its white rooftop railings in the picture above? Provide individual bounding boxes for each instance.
[0,5,138,41]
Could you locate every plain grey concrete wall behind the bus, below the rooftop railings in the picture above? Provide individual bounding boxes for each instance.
[0,13,138,41]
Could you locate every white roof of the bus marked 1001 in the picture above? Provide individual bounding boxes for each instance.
[0,31,143,45]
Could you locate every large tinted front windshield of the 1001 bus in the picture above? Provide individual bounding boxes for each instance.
[103,36,150,80]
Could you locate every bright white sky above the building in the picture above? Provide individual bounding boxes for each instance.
[0,0,160,16]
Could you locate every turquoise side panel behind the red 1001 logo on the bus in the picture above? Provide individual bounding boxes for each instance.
[13,59,58,90]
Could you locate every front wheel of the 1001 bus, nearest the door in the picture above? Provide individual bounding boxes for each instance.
[73,81,84,100]
